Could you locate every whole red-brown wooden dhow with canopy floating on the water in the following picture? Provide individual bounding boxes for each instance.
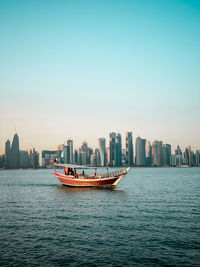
[53,164,130,187]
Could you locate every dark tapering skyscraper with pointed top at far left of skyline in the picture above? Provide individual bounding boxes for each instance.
[9,134,20,169]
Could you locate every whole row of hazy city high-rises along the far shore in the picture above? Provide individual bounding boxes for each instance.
[0,132,200,169]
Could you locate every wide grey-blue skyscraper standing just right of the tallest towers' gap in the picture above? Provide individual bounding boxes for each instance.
[135,137,146,166]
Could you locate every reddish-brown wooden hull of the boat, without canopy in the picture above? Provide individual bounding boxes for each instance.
[53,172,128,187]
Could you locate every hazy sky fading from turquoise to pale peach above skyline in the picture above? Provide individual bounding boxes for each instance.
[0,0,200,153]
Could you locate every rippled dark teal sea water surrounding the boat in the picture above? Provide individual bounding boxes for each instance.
[0,168,200,266]
